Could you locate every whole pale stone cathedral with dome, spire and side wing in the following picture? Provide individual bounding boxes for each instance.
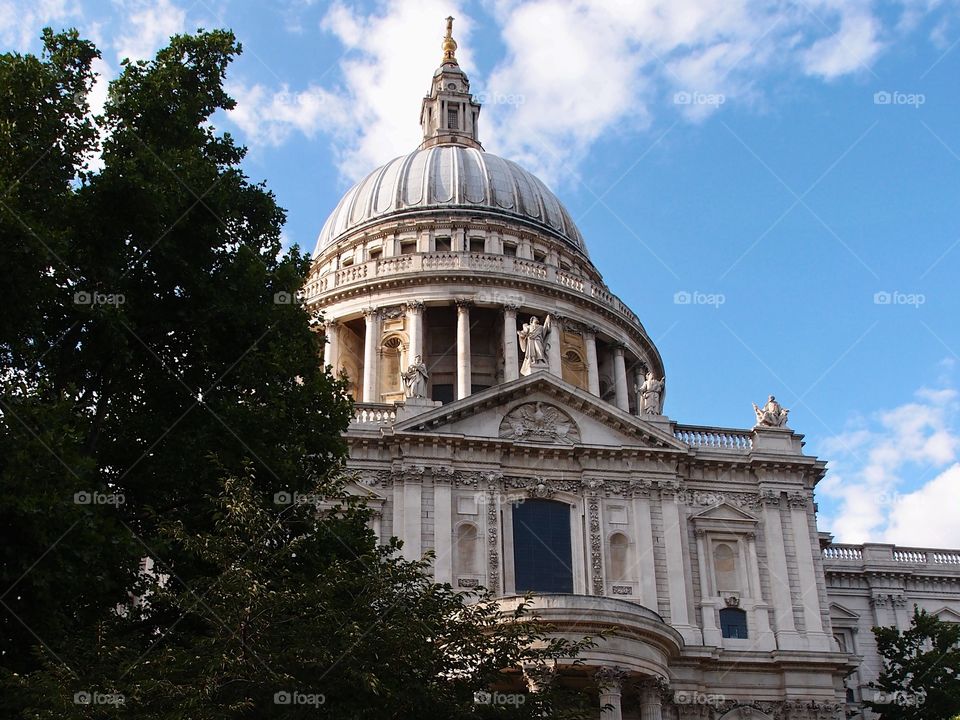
[305,19,960,720]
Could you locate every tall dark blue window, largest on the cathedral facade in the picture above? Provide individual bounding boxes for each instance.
[513,500,573,593]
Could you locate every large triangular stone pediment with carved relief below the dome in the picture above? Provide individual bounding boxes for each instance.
[393,372,687,451]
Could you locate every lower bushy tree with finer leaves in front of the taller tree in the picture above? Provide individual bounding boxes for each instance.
[15,473,596,720]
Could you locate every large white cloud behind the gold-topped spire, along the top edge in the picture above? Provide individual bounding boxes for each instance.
[221,0,929,188]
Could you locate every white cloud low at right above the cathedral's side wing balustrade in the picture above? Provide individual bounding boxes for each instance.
[817,388,960,547]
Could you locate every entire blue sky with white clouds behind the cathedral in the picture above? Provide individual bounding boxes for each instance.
[0,0,960,547]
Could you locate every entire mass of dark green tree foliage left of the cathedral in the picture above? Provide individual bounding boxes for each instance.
[0,30,596,720]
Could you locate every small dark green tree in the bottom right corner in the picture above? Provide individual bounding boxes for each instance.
[864,607,960,720]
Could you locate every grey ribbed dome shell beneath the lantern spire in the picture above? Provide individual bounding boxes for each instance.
[314,144,587,256]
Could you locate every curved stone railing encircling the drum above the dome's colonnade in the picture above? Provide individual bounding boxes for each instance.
[304,252,640,324]
